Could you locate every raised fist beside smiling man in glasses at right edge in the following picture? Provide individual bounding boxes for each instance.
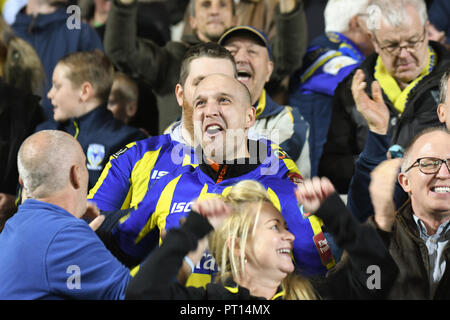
[369,158,402,232]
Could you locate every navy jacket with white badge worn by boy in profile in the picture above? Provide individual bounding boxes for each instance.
[36,105,147,188]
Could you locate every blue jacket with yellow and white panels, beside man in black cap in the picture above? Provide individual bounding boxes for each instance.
[289,32,364,176]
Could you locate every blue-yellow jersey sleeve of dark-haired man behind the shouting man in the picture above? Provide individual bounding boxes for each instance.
[88,142,138,211]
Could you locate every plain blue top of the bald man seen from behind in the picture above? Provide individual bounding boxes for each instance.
[0,199,130,300]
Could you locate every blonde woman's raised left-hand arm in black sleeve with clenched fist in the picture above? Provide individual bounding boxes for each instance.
[126,199,231,299]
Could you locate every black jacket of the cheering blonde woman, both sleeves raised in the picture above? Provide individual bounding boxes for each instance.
[126,194,398,300]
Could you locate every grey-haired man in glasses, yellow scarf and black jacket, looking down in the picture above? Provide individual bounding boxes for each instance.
[319,0,450,193]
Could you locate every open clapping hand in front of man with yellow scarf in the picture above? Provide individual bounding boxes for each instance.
[351,69,390,135]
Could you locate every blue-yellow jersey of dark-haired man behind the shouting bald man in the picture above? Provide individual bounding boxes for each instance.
[88,134,196,211]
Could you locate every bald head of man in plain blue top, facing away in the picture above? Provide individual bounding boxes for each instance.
[17,130,85,199]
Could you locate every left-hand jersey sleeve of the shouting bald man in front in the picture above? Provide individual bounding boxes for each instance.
[113,176,171,261]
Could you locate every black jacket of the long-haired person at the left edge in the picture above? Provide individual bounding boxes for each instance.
[0,78,44,194]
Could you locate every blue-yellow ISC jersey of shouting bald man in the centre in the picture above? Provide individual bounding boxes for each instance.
[113,145,334,286]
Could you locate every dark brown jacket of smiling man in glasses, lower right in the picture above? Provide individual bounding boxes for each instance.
[376,201,450,300]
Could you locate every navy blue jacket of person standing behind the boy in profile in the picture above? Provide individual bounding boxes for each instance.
[12,7,103,119]
